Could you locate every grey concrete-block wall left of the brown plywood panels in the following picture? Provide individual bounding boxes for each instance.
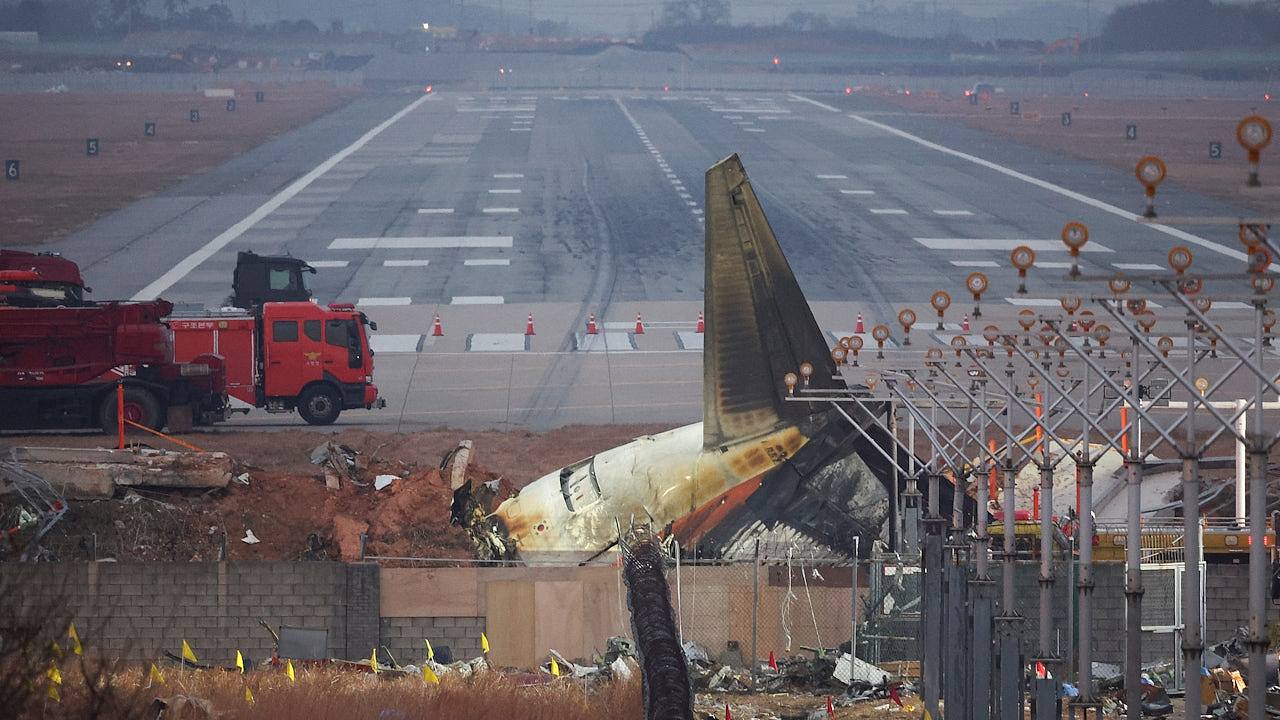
[0,562,379,664]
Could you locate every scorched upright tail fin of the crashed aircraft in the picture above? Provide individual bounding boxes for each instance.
[703,155,845,448]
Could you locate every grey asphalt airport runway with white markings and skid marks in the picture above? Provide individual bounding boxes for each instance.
[22,91,1269,429]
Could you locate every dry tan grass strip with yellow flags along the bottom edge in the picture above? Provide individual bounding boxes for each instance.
[23,666,644,720]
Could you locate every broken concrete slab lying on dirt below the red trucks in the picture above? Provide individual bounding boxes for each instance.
[0,447,233,500]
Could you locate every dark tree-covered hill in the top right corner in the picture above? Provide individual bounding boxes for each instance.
[1100,0,1280,53]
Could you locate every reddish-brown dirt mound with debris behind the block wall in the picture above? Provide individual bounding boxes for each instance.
[0,425,666,561]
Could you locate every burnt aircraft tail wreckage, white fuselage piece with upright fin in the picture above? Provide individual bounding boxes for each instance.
[465,155,905,562]
